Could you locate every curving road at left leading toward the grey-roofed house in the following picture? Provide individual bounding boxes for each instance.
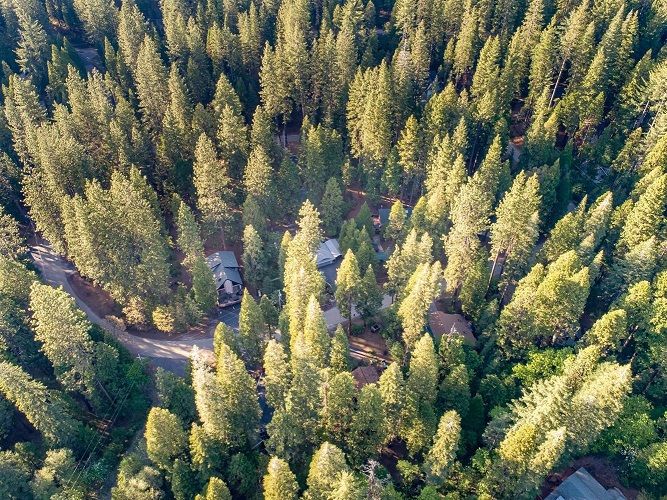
[30,240,213,375]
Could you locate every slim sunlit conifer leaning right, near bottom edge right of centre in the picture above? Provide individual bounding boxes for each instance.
[424,410,461,484]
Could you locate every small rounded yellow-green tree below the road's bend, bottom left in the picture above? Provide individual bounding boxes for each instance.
[144,407,187,470]
